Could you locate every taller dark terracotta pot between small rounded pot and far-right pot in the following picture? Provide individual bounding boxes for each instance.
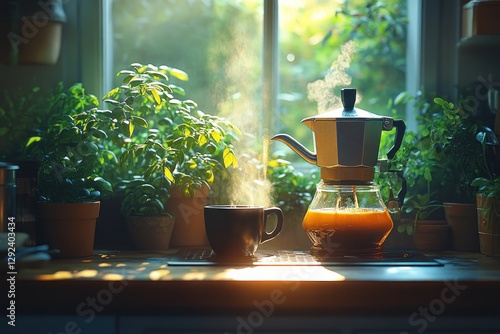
[443,203,479,252]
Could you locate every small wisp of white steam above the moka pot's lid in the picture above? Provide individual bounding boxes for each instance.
[307,41,356,113]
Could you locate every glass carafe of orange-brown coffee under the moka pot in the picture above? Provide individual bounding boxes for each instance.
[302,181,393,254]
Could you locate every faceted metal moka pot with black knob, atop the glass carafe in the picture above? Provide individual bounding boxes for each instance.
[271,88,406,184]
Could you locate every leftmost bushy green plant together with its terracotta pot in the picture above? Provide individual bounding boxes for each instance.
[28,100,114,257]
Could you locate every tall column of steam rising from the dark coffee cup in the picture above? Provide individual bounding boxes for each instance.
[213,29,272,207]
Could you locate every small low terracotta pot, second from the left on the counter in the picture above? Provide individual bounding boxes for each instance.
[126,216,174,250]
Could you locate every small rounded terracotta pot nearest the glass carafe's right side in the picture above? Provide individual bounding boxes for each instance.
[413,220,451,251]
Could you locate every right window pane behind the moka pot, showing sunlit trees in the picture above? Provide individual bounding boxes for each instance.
[275,0,407,159]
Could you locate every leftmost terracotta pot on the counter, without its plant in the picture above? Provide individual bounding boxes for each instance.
[38,202,100,257]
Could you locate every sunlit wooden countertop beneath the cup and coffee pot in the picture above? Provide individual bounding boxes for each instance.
[11,251,500,316]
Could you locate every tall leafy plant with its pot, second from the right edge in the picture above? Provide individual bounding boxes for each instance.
[431,98,486,252]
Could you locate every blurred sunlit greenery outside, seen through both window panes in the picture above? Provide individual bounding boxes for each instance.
[112,0,408,161]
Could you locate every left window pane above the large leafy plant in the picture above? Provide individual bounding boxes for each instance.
[112,0,263,128]
